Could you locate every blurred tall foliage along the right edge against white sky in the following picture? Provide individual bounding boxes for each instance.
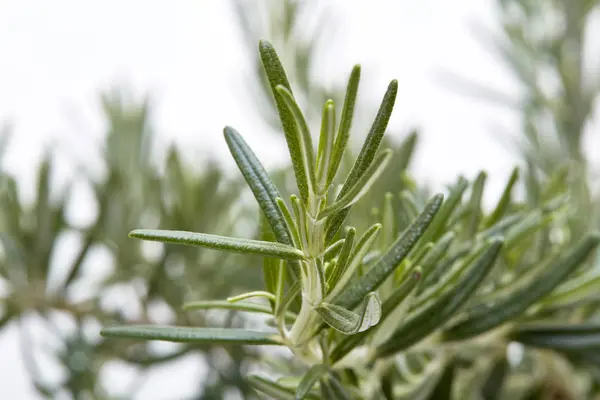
[440,0,600,398]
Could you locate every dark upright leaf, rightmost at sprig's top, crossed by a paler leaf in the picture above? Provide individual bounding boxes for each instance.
[326,79,398,243]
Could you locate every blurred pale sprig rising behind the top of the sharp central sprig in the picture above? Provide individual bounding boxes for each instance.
[233,0,428,238]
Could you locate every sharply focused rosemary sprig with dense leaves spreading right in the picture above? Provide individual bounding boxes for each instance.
[102,41,600,399]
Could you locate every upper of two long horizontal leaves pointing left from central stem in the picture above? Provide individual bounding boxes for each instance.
[129,229,305,260]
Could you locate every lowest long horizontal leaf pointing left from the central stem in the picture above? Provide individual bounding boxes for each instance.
[100,325,282,345]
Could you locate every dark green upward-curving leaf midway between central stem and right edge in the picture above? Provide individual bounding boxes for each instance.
[374,239,503,358]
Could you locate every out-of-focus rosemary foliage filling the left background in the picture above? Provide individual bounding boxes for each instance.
[0,93,260,399]
